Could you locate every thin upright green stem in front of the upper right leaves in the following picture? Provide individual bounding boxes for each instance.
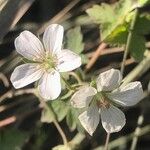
[121,8,139,75]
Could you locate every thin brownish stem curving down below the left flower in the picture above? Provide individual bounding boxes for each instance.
[38,97,68,145]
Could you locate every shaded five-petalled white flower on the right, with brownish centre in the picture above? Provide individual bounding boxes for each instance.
[71,69,143,135]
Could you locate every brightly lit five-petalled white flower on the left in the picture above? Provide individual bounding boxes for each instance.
[10,24,81,100]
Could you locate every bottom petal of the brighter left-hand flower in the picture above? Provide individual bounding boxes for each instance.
[38,70,61,100]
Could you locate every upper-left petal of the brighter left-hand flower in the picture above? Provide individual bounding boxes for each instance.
[15,31,44,60]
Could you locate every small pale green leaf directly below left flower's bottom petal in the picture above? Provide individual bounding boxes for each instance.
[51,99,69,121]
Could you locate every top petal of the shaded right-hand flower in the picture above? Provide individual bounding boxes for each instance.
[96,69,122,91]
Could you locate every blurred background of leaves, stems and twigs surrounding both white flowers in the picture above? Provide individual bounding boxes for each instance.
[0,0,150,150]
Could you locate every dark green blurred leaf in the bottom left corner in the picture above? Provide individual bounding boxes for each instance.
[0,129,27,150]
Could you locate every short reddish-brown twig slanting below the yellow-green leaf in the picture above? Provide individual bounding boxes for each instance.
[86,43,107,71]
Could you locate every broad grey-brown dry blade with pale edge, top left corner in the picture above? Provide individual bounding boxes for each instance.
[0,0,34,40]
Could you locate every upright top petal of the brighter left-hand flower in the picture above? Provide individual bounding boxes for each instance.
[43,24,64,53]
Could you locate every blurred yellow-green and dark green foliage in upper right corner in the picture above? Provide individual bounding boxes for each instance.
[86,0,150,61]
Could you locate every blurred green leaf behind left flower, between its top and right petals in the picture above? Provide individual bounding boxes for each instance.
[66,27,84,54]
